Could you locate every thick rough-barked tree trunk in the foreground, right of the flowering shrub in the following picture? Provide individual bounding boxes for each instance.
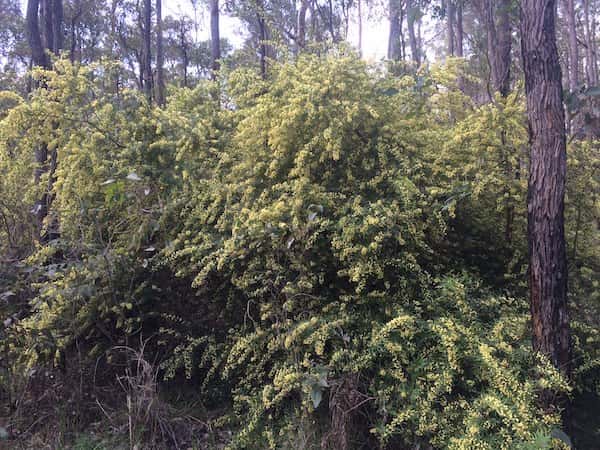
[521,0,571,408]
